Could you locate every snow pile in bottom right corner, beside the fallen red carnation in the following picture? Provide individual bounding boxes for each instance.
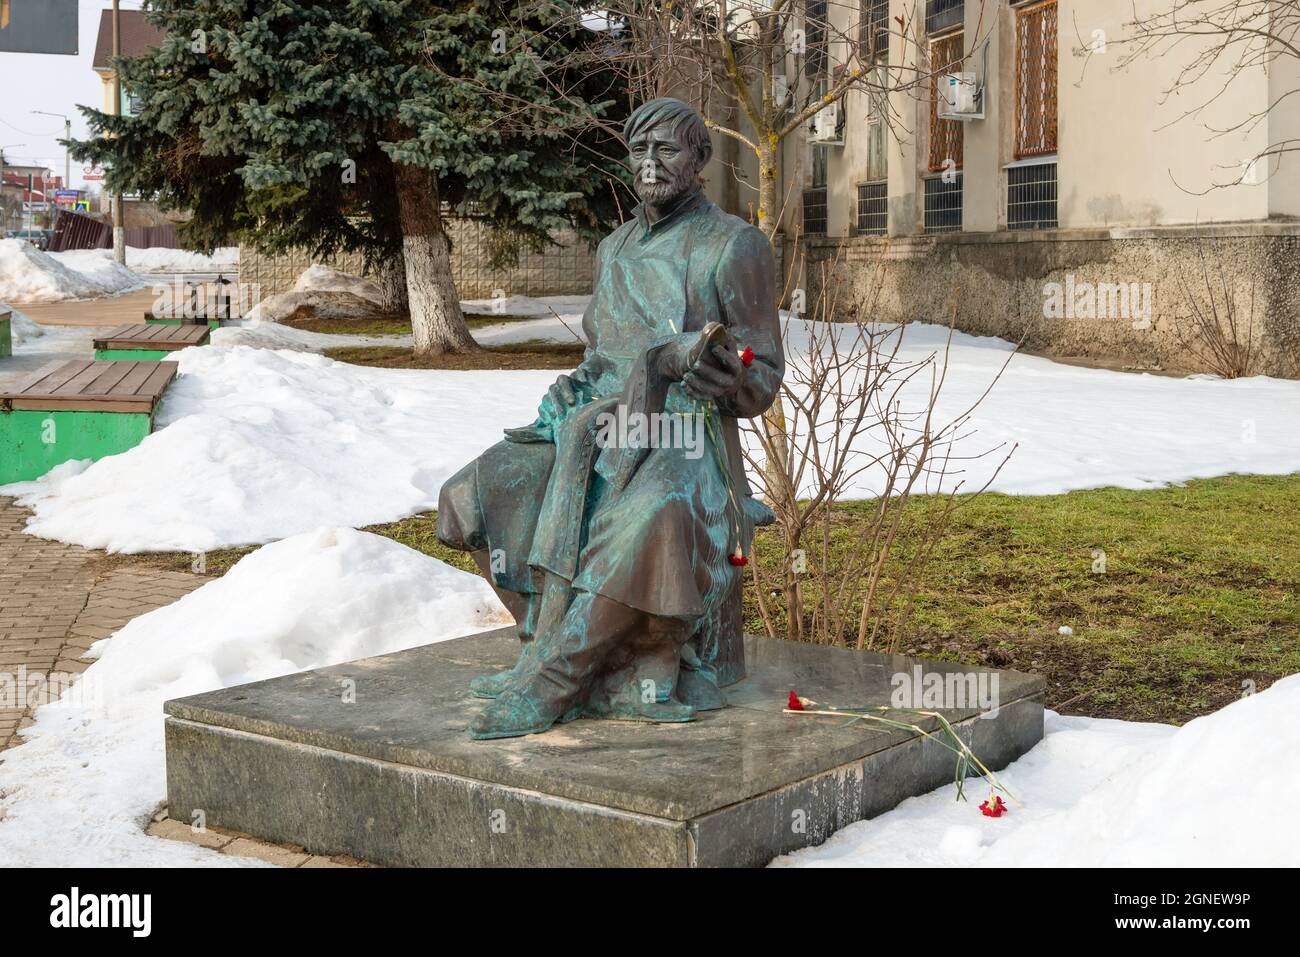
[775,675,1300,867]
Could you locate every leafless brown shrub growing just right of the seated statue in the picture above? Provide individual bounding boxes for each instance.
[745,250,1014,651]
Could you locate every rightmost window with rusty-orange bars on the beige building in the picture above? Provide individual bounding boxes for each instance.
[1015,0,1057,159]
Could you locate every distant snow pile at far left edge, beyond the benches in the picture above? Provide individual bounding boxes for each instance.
[0,239,144,303]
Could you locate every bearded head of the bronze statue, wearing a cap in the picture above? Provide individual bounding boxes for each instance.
[623,96,714,205]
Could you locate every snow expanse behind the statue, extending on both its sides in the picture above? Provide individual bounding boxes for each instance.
[5,310,1300,551]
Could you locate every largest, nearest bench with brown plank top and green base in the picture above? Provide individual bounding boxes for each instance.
[0,360,177,485]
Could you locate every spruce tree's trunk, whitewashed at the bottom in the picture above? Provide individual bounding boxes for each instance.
[395,164,480,356]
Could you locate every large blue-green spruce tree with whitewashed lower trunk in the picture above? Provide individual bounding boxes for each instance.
[73,0,627,355]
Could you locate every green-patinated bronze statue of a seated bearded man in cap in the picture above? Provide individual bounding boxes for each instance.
[438,99,785,739]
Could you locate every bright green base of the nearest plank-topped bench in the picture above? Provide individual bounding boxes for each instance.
[0,410,153,485]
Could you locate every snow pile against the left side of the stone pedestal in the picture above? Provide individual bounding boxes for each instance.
[0,528,511,867]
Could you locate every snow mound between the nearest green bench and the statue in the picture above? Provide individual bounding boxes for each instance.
[7,346,555,551]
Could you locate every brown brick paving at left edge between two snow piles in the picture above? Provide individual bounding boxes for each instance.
[0,498,205,752]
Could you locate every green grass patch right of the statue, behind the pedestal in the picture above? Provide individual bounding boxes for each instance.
[746,475,1300,722]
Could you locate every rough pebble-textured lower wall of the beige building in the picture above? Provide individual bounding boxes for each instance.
[803,224,1300,376]
